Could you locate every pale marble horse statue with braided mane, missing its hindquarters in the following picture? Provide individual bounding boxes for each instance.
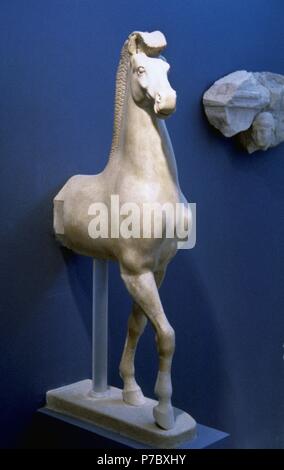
[54,31,191,429]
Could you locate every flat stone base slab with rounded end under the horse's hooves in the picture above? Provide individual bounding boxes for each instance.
[46,380,196,448]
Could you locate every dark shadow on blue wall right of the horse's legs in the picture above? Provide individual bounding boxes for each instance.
[161,253,228,427]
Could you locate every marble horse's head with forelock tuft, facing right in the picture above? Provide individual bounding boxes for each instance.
[128,31,176,119]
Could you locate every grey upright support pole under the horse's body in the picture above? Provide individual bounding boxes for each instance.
[92,259,108,396]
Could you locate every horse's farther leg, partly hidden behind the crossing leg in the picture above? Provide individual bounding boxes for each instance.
[119,302,147,406]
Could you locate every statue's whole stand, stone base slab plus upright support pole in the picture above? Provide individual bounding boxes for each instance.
[44,259,199,448]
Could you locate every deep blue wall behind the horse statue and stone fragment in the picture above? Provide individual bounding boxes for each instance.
[0,0,284,447]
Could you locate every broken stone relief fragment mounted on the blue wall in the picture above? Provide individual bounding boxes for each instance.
[203,70,284,153]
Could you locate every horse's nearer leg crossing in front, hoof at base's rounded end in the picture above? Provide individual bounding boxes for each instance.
[121,267,175,429]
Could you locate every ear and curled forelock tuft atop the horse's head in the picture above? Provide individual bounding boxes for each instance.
[128,31,167,57]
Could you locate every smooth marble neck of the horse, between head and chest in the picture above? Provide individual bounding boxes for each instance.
[107,87,178,185]
